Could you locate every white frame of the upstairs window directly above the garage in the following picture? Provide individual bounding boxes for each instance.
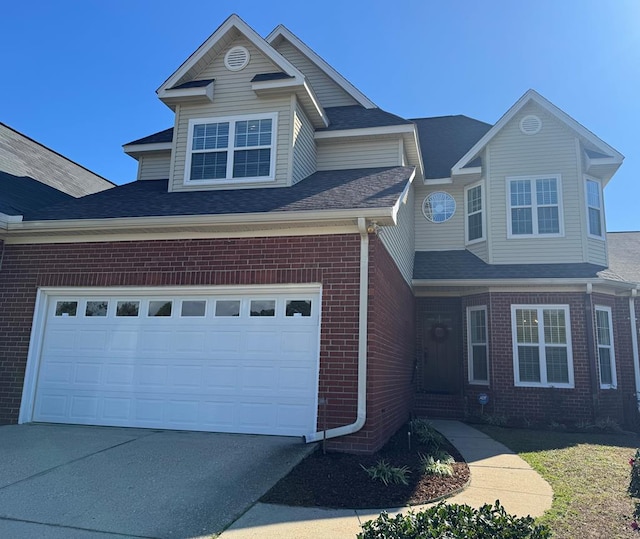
[184,112,278,185]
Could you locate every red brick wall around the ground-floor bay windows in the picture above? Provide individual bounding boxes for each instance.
[419,292,635,430]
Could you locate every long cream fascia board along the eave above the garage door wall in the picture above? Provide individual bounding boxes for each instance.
[8,206,393,232]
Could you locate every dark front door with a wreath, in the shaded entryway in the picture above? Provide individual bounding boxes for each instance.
[420,308,462,394]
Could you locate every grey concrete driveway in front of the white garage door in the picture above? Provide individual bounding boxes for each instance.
[0,425,313,539]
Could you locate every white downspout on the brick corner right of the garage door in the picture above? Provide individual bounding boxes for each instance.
[304,217,369,443]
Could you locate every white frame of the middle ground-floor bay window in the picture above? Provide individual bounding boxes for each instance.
[511,304,575,389]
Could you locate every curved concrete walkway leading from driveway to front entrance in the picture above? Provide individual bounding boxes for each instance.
[221,420,553,539]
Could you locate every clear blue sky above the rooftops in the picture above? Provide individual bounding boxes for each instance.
[0,0,640,230]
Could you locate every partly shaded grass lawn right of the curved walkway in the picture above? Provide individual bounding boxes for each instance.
[477,425,640,539]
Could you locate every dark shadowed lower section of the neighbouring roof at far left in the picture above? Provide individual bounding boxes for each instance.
[0,171,75,215]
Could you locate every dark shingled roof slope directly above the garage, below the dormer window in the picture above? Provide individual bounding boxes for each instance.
[24,167,415,221]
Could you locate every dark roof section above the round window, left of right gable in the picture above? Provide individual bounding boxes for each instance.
[413,115,491,180]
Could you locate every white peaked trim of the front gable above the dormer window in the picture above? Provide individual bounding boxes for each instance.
[156,14,304,98]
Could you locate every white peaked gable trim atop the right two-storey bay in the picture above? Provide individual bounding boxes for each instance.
[451,90,624,174]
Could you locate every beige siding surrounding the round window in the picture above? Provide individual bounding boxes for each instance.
[414,184,466,251]
